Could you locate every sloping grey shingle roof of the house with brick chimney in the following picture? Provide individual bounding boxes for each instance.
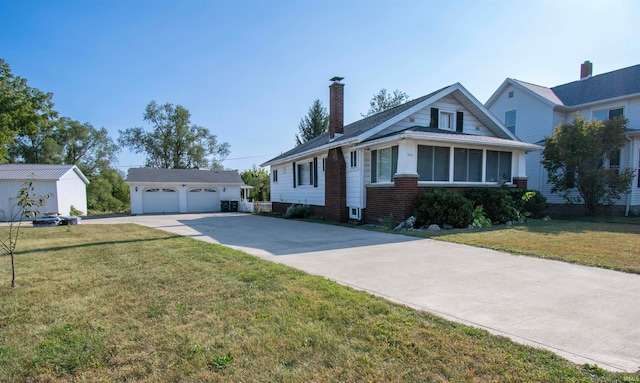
[265,86,448,163]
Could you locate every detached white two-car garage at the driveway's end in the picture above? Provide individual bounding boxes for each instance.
[127,168,248,214]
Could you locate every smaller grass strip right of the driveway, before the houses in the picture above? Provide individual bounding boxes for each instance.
[360,217,640,274]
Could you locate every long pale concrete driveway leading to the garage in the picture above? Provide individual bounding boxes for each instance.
[83,213,640,372]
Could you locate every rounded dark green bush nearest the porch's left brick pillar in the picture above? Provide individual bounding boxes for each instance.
[414,189,473,228]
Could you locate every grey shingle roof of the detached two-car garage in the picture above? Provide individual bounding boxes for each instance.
[127,168,244,184]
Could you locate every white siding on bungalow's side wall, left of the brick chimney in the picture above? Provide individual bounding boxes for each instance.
[271,154,328,206]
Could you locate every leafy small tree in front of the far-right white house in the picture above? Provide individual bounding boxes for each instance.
[542,114,634,215]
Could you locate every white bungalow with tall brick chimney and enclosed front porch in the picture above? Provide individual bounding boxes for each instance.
[262,77,540,223]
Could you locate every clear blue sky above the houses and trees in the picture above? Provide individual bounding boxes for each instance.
[0,0,640,170]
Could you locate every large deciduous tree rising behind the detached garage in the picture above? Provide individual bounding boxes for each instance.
[118,101,229,169]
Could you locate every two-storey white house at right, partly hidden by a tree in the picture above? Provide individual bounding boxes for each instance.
[485,61,640,213]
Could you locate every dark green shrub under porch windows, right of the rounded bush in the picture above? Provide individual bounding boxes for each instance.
[467,187,518,224]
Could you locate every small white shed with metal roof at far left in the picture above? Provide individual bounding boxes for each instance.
[0,164,89,221]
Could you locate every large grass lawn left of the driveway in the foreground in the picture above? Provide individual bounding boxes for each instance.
[0,225,640,382]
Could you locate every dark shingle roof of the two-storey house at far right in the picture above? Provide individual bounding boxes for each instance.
[551,65,640,106]
